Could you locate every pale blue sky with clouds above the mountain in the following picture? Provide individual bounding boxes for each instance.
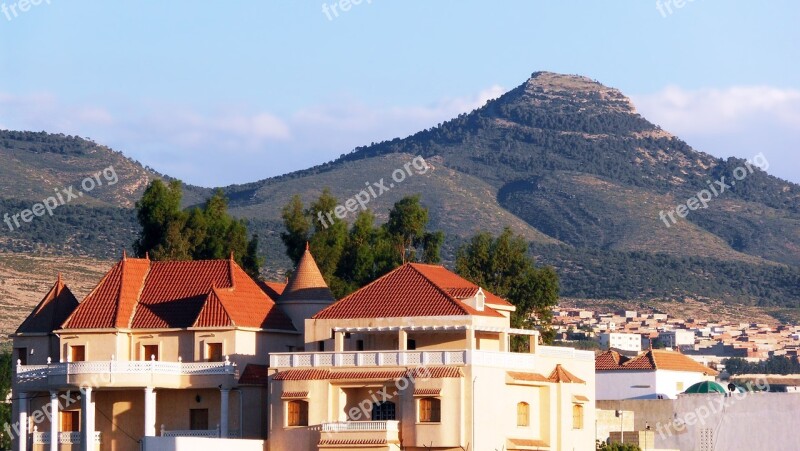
[0,0,800,186]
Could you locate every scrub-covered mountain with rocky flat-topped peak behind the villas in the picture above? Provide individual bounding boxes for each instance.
[0,72,800,322]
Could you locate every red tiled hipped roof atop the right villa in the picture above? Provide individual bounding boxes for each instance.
[313,263,503,319]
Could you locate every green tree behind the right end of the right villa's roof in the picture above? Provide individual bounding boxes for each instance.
[456,228,559,347]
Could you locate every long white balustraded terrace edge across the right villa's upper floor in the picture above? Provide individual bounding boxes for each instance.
[269,346,594,369]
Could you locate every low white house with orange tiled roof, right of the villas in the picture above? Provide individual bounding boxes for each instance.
[595,349,719,400]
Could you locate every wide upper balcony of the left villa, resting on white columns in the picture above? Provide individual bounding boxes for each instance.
[14,360,237,389]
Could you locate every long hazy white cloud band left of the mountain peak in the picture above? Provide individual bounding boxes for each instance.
[0,86,503,186]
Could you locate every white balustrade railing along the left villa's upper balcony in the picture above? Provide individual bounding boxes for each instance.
[16,360,236,383]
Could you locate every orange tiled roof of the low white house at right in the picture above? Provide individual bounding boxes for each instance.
[594,349,719,376]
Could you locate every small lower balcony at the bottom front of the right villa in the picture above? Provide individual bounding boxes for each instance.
[319,421,400,449]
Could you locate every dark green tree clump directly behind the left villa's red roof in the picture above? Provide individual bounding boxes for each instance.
[133,179,263,278]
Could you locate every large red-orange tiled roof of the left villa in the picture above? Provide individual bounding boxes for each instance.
[62,257,295,330]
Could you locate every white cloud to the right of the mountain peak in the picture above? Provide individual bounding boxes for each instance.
[633,86,800,182]
